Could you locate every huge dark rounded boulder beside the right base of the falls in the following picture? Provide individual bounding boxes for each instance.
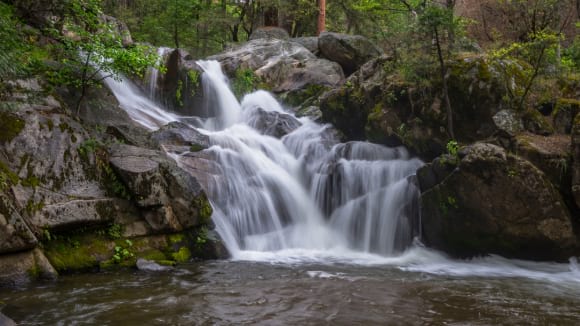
[418,143,578,259]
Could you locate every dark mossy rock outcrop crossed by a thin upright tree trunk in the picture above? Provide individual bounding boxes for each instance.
[320,56,532,159]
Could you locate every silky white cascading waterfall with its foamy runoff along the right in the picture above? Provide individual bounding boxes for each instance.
[107,61,580,286]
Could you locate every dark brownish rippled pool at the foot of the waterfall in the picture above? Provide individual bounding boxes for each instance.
[0,261,580,325]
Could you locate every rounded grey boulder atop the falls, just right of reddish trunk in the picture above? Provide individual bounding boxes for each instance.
[318,32,383,75]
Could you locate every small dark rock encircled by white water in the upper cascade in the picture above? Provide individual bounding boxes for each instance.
[246,108,302,138]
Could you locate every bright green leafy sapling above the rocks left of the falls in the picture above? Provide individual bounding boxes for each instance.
[46,0,157,112]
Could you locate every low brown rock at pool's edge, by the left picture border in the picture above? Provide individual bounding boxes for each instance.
[0,249,57,288]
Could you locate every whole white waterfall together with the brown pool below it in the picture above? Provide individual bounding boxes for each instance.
[0,56,580,325]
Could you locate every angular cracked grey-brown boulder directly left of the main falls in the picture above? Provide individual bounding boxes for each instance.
[110,144,212,231]
